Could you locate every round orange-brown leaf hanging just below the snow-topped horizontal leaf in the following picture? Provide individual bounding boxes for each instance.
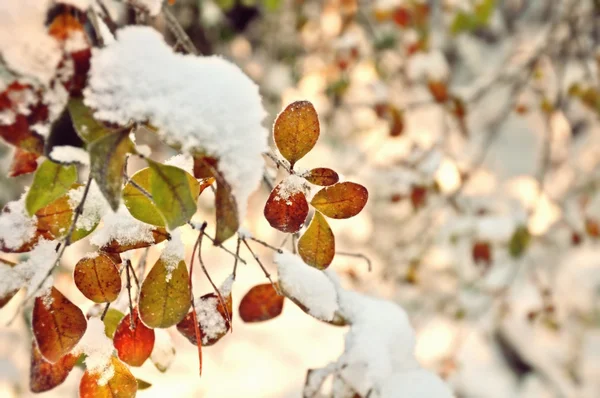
[73,253,121,303]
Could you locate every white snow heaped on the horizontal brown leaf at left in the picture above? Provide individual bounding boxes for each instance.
[90,205,154,247]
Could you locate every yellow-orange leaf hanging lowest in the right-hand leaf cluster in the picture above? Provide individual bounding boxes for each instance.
[298,211,335,269]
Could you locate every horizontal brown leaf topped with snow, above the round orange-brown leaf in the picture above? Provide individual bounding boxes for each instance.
[90,206,168,253]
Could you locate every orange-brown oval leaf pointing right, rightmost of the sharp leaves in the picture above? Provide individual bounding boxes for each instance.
[310,182,369,219]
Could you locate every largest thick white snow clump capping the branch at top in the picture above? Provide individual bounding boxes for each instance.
[84,26,267,220]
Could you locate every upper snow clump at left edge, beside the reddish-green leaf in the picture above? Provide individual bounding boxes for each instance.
[0,192,37,249]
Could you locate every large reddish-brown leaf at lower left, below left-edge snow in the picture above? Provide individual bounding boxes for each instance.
[31,287,87,362]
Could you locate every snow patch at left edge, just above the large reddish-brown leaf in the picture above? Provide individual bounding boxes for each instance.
[0,240,57,297]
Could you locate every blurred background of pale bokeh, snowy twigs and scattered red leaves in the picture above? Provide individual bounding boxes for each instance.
[0,0,600,398]
